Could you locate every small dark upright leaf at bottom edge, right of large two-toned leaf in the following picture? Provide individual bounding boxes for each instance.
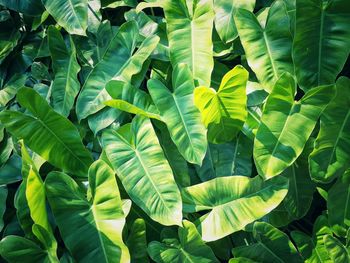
[126,218,149,263]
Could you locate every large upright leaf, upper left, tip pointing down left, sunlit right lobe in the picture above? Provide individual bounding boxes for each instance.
[76,22,159,120]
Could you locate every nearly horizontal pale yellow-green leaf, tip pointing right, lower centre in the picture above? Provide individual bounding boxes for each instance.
[182,176,288,241]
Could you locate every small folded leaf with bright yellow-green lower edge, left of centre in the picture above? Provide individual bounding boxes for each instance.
[104,80,160,120]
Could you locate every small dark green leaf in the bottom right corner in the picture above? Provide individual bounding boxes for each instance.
[323,235,350,263]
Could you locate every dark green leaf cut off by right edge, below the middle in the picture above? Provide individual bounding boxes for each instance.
[327,170,350,237]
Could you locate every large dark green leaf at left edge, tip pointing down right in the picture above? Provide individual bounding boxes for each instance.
[0,88,92,177]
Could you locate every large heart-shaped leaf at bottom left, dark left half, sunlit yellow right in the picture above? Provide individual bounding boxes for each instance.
[45,160,129,262]
